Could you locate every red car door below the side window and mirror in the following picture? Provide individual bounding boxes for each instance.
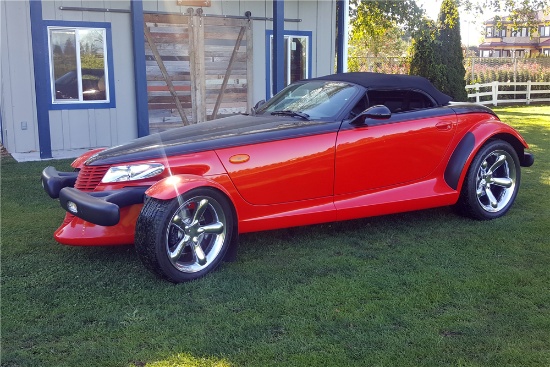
[334,108,456,195]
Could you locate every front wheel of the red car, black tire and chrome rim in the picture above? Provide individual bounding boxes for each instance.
[135,188,235,283]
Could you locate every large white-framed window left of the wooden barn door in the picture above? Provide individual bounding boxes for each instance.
[48,26,110,105]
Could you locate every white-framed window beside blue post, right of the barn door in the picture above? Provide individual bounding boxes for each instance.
[269,32,311,95]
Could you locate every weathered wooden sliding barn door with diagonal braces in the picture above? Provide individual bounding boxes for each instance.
[144,13,252,133]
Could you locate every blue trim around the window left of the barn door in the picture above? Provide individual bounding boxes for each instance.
[43,20,116,110]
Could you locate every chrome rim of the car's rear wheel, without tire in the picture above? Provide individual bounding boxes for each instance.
[476,150,517,213]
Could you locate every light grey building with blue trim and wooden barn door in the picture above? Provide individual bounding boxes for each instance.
[0,0,347,158]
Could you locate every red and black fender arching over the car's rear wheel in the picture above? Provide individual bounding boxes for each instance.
[444,121,529,191]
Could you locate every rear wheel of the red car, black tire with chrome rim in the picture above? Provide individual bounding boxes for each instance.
[456,140,521,220]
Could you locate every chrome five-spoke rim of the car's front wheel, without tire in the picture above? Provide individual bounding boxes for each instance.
[165,196,227,273]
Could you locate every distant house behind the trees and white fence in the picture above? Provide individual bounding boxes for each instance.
[479,11,550,57]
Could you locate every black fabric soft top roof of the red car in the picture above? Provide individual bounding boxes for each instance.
[314,72,452,106]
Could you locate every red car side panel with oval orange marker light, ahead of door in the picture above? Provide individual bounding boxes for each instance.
[216,131,338,205]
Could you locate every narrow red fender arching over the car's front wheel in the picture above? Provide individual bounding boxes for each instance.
[145,174,230,200]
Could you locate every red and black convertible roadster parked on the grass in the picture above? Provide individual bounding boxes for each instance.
[42,73,534,282]
